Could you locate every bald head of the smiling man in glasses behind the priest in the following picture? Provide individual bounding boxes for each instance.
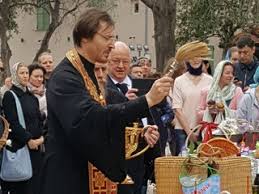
[108,41,131,82]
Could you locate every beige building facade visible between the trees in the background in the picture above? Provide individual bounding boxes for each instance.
[6,0,221,69]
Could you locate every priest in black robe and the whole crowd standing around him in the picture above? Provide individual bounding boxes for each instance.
[0,9,259,194]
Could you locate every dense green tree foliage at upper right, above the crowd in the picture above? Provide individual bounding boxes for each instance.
[176,0,256,48]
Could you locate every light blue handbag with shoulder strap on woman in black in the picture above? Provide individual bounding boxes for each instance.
[0,90,32,182]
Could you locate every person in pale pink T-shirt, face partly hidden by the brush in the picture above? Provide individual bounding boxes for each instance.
[173,56,212,155]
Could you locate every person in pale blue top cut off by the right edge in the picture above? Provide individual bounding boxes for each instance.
[237,67,259,126]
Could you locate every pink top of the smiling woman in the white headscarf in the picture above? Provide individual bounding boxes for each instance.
[197,87,244,122]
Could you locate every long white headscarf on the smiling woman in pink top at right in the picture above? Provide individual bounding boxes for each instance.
[203,60,236,123]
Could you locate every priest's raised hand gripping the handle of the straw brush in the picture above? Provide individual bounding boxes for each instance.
[146,76,173,108]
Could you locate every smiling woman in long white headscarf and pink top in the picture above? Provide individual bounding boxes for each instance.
[198,60,243,123]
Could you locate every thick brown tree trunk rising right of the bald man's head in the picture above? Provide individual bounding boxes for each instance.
[152,0,176,72]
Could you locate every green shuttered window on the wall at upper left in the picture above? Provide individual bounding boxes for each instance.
[37,0,50,31]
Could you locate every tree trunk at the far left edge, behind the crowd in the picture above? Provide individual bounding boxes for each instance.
[0,29,12,85]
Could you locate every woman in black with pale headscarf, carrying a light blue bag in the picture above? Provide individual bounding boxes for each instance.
[1,63,44,194]
